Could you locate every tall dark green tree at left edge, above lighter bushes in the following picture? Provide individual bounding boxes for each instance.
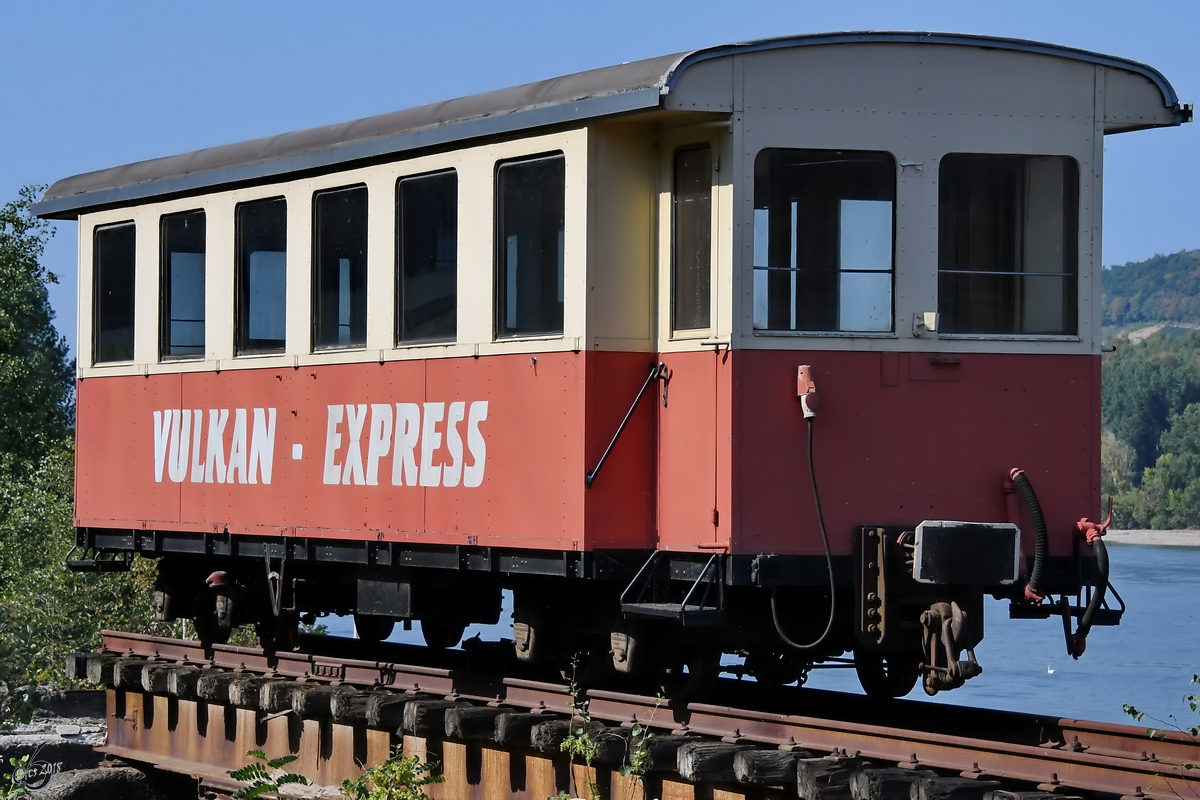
[0,186,74,462]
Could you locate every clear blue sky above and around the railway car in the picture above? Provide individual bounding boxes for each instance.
[0,0,1200,344]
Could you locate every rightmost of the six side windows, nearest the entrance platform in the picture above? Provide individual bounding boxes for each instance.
[494,154,566,337]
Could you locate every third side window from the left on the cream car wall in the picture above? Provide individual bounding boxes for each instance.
[236,198,288,354]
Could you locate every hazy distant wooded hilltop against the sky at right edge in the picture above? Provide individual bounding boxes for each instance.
[1104,249,1200,327]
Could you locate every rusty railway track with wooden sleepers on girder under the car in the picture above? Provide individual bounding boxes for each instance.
[77,632,1200,800]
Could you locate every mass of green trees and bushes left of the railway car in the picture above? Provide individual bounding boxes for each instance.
[0,187,175,723]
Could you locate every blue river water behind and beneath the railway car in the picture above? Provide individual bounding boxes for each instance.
[323,543,1200,724]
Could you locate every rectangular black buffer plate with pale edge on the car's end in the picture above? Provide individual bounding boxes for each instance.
[912,519,1021,587]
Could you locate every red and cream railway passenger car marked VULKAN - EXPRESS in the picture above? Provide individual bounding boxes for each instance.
[37,32,1192,694]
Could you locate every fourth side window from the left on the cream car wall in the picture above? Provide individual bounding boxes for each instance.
[312,186,367,350]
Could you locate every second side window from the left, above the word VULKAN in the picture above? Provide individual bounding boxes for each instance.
[160,211,205,359]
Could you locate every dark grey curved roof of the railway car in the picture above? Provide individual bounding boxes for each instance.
[34,31,1186,218]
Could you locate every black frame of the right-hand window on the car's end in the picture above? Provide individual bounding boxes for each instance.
[935,150,1088,342]
